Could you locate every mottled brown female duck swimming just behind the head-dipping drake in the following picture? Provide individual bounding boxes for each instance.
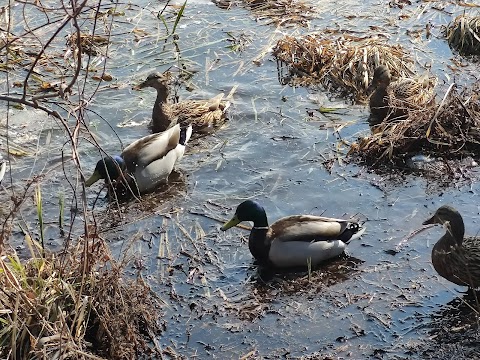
[134,72,230,134]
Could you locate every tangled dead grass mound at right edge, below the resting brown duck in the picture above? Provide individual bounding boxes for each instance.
[349,82,480,166]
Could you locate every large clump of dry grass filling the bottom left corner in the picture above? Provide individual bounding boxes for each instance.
[0,239,160,359]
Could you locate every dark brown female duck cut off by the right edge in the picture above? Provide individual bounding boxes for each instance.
[423,205,480,288]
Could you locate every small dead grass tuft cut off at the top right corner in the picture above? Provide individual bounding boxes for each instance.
[445,14,480,55]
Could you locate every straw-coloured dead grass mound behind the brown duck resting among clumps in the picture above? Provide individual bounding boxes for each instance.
[273,34,413,101]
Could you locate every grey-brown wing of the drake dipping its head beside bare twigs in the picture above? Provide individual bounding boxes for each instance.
[122,124,180,173]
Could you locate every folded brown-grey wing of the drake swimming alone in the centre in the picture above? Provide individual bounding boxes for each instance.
[269,215,365,242]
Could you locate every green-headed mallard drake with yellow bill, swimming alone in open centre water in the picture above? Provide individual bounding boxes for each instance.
[221,200,365,268]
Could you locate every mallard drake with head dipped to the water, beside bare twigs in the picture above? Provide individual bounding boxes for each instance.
[85,124,192,193]
